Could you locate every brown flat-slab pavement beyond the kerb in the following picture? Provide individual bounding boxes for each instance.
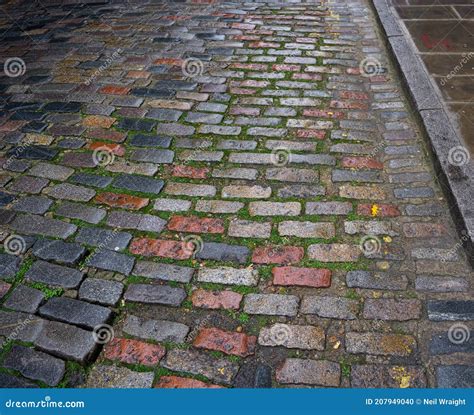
[393,0,474,156]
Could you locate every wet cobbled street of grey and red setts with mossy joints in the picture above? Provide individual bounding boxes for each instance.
[0,0,474,388]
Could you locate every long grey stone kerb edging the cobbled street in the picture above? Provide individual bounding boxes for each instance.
[372,0,474,267]
